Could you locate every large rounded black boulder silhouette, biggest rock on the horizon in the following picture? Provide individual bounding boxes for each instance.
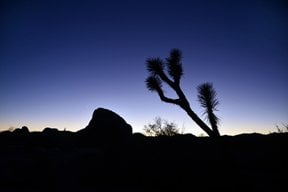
[78,108,132,144]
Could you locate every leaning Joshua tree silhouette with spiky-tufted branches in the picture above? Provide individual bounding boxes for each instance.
[146,49,220,137]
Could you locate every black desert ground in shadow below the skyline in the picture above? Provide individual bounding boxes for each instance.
[0,130,288,191]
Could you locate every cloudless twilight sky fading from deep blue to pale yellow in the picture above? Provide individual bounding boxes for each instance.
[0,0,288,135]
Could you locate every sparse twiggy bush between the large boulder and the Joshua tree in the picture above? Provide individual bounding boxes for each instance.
[144,117,180,137]
